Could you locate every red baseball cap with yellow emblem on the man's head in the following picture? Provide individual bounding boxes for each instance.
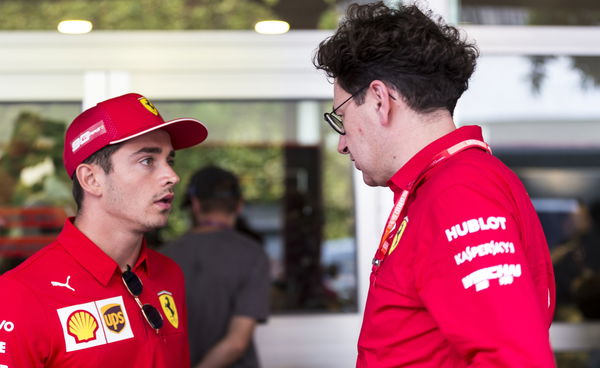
[63,93,208,178]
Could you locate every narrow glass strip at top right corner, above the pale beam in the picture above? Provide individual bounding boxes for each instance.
[460,0,600,26]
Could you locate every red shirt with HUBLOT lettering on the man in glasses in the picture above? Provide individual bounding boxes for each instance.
[357,126,555,368]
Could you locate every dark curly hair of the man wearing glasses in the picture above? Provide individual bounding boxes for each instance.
[313,1,479,114]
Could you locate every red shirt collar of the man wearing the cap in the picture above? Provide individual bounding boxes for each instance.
[57,217,150,286]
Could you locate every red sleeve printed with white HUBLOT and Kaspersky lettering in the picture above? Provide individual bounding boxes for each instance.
[417,184,554,367]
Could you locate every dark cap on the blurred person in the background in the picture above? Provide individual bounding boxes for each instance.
[183,166,242,213]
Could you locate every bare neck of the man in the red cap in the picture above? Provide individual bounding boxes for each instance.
[74,211,143,271]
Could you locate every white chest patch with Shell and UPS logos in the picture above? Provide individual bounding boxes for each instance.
[56,296,133,352]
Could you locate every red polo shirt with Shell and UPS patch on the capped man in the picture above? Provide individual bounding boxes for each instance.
[0,219,189,368]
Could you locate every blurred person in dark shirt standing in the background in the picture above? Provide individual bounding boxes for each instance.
[163,166,270,368]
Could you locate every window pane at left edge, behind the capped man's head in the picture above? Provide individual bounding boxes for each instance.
[0,103,81,273]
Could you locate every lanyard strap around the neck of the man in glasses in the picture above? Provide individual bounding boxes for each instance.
[373,139,492,267]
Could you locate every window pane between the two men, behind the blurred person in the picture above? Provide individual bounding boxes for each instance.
[155,101,357,313]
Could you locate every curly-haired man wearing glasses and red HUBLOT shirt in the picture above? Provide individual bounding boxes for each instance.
[314,2,555,368]
